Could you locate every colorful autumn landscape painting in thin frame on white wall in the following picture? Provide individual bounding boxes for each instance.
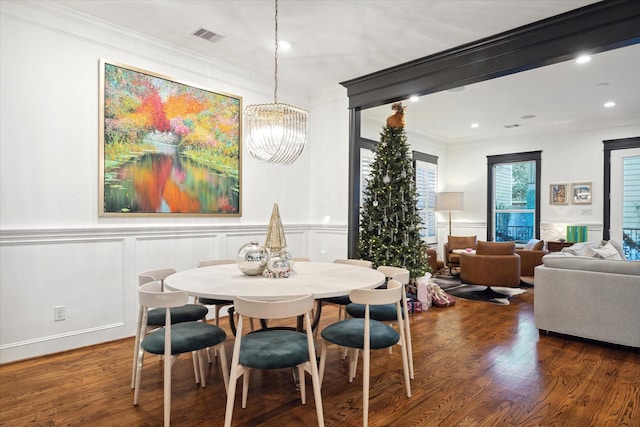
[100,60,242,216]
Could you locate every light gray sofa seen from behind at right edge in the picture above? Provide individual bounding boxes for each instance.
[534,252,640,347]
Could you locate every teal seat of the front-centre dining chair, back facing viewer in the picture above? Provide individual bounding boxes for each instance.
[240,329,309,369]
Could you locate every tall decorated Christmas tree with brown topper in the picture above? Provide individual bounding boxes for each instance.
[358,103,431,278]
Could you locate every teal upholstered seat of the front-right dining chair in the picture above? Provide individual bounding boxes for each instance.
[321,320,400,349]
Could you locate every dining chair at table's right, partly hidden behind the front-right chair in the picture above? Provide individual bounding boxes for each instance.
[346,265,413,379]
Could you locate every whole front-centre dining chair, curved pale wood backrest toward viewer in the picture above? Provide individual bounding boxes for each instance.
[224,295,324,427]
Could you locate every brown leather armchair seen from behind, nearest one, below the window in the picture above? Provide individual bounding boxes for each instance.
[460,241,520,290]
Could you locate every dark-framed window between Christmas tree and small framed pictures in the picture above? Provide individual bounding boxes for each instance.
[487,151,540,243]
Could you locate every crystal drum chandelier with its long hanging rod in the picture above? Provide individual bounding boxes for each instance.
[244,0,309,164]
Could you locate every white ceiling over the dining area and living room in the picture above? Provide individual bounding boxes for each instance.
[47,0,640,141]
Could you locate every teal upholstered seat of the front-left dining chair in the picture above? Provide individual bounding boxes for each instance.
[142,318,227,355]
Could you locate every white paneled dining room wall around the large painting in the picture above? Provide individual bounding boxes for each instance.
[0,1,348,363]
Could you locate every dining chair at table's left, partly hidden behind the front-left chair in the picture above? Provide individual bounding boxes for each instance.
[131,268,209,389]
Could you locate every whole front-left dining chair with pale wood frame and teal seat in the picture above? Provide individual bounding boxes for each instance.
[133,282,229,426]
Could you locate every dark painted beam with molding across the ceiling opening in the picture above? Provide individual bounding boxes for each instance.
[341,0,640,108]
